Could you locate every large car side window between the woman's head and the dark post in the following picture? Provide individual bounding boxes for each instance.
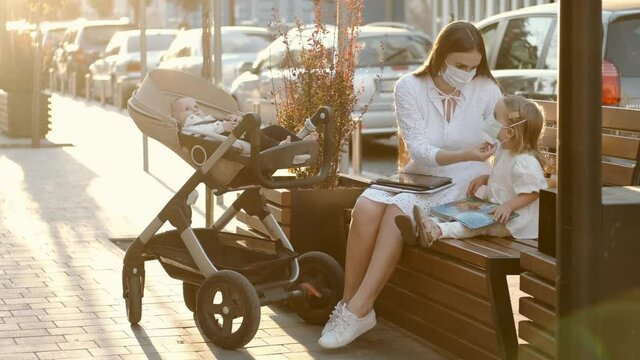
[496,17,553,70]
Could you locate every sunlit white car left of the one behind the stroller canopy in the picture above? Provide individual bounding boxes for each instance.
[89,29,178,103]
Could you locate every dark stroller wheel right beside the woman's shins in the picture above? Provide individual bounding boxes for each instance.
[289,251,344,325]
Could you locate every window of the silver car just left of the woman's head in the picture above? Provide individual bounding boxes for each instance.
[358,35,431,67]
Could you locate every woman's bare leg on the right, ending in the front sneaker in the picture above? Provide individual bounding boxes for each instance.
[347,205,403,317]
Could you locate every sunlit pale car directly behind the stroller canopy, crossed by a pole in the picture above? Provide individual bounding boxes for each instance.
[158,26,273,89]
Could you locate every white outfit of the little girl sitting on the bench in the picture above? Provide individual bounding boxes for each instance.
[438,150,548,239]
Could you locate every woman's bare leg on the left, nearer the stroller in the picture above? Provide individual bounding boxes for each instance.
[342,197,387,302]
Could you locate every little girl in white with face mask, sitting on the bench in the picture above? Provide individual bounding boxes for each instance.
[413,96,547,246]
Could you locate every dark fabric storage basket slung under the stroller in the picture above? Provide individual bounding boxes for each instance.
[148,228,298,284]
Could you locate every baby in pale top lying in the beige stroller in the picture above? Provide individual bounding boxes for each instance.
[171,97,318,151]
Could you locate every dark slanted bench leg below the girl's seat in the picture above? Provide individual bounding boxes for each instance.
[487,259,518,360]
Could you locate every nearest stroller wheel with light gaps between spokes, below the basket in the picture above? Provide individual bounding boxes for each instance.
[196,270,260,349]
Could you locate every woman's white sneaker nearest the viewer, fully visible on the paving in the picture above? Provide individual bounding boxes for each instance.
[318,306,376,349]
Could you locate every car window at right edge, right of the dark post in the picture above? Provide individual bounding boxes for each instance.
[605,15,640,76]
